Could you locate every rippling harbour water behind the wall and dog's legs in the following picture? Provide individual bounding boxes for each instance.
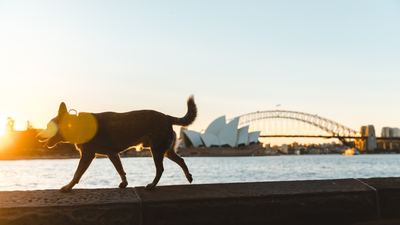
[0,154,400,191]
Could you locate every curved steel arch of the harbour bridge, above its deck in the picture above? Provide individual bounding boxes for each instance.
[229,110,358,137]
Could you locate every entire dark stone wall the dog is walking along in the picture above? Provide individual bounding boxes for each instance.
[0,178,400,225]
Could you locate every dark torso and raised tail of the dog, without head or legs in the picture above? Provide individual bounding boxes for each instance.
[79,96,197,154]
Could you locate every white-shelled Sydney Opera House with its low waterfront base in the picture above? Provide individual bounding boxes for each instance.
[178,116,263,156]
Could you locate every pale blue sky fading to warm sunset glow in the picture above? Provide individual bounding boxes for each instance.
[0,0,400,144]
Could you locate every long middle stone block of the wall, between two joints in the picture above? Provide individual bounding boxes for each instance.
[135,179,376,224]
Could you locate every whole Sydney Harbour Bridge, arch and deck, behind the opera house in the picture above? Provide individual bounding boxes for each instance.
[230,110,400,150]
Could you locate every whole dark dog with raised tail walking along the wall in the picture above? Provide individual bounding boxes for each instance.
[37,95,197,192]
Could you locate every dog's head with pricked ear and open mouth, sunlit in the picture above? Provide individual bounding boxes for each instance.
[36,102,69,148]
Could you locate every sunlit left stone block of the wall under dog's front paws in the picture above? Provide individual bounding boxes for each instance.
[0,188,140,225]
